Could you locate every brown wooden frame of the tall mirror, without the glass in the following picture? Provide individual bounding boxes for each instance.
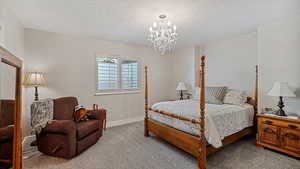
[0,46,22,169]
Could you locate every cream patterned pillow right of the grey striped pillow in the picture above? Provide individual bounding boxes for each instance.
[223,89,247,105]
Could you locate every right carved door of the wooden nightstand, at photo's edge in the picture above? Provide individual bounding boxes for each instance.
[281,129,300,153]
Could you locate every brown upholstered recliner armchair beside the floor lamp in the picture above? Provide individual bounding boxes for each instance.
[37,97,106,158]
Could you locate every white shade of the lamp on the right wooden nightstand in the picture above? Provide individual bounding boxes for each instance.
[268,82,296,97]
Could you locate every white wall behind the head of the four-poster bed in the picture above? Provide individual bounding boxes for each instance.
[173,32,257,97]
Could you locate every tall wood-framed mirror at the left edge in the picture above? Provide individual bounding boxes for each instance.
[0,47,22,169]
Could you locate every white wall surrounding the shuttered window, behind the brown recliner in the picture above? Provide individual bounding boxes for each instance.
[24,29,172,135]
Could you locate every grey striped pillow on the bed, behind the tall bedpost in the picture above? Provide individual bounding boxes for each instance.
[194,87,227,104]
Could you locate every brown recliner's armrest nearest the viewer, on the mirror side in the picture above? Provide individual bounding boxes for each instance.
[42,120,76,134]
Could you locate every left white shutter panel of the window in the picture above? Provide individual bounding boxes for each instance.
[96,57,119,90]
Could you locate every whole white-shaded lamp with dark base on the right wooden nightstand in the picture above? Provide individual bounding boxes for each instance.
[268,82,296,116]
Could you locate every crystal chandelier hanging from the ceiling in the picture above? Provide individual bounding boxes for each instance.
[148,15,178,55]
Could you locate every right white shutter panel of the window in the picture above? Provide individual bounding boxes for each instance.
[121,60,138,89]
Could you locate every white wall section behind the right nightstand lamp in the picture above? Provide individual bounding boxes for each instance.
[258,17,300,115]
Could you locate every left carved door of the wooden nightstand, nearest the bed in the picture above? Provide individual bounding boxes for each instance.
[259,124,280,146]
